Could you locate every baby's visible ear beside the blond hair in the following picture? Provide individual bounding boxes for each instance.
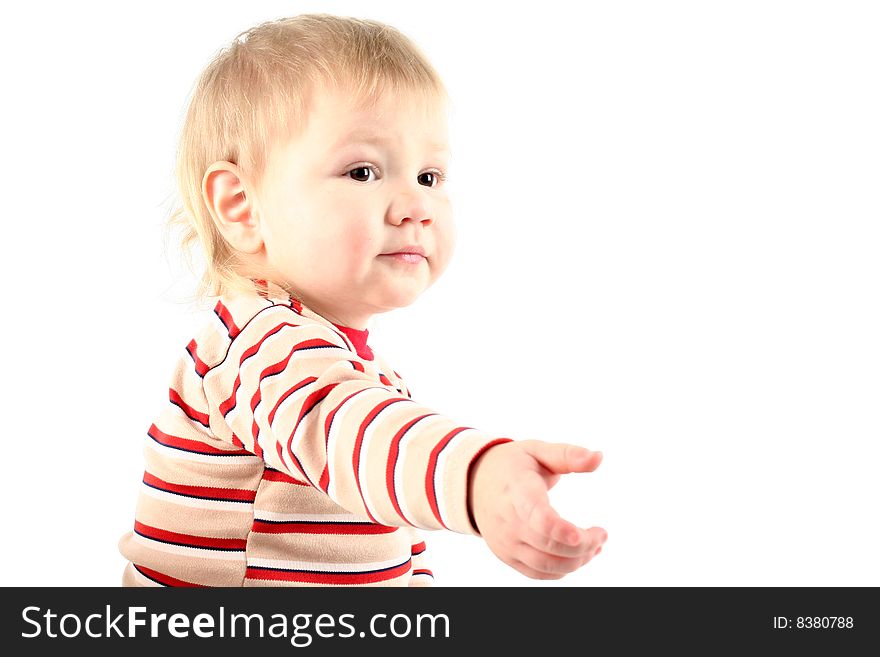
[202,162,263,254]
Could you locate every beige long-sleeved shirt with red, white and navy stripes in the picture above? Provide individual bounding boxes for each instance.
[119,282,510,586]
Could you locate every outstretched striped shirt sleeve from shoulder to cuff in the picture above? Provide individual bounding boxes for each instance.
[203,306,511,534]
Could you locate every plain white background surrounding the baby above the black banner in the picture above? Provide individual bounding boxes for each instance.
[0,0,880,587]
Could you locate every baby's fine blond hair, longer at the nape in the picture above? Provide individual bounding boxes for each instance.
[168,14,448,297]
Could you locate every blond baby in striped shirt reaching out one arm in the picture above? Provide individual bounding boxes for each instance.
[119,14,606,586]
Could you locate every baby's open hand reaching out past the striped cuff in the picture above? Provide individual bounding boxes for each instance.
[468,440,608,579]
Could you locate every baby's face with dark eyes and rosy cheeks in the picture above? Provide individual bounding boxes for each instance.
[251,83,454,328]
